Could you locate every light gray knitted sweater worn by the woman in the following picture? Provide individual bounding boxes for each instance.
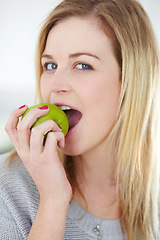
[0,154,129,240]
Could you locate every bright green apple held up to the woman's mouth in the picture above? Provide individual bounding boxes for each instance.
[22,103,69,135]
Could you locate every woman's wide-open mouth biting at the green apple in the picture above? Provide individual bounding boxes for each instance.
[58,106,82,130]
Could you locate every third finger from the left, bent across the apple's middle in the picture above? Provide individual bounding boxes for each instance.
[30,120,62,154]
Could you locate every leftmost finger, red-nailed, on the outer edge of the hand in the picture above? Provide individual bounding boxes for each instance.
[5,105,27,147]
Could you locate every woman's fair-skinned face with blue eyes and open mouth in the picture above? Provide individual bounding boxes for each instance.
[41,17,121,155]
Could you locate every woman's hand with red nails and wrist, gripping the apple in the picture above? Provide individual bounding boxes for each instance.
[6,106,72,204]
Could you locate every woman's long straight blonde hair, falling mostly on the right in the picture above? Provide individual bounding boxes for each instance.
[27,0,160,240]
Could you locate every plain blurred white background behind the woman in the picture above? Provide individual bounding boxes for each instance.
[0,0,160,153]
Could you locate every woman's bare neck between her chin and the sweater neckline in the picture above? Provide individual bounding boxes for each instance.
[74,144,121,219]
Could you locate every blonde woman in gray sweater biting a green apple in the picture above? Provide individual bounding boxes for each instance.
[1,0,159,240]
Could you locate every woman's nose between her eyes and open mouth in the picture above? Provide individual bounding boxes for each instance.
[51,69,71,94]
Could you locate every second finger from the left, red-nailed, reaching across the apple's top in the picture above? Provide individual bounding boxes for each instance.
[17,108,49,152]
